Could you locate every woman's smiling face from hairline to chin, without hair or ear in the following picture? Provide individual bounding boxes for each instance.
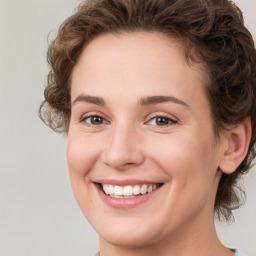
[67,32,223,246]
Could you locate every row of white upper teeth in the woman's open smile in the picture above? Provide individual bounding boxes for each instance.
[102,184,159,197]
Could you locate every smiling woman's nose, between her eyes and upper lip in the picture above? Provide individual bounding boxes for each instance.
[102,124,144,170]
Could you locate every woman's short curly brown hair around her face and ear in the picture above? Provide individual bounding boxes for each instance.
[39,0,256,220]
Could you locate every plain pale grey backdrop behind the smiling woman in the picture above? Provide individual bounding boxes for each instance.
[0,0,256,256]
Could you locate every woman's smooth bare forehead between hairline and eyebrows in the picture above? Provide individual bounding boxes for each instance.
[71,32,209,106]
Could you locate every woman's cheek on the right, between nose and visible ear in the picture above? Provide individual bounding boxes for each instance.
[149,130,218,186]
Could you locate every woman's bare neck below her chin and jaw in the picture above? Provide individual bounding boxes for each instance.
[100,211,234,256]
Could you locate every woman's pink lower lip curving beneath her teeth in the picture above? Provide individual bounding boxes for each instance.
[95,184,161,209]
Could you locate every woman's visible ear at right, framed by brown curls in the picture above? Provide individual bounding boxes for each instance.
[219,117,251,174]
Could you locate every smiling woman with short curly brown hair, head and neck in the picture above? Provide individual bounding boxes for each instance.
[40,0,256,256]
